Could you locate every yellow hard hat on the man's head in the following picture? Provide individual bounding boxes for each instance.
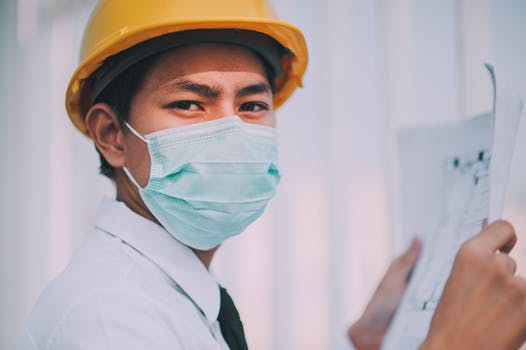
[66,0,308,135]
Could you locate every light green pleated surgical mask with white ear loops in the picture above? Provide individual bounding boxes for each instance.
[123,116,280,250]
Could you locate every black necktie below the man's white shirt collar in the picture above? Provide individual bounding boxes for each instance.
[217,287,248,350]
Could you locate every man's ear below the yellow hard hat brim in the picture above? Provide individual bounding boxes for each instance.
[85,103,125,168]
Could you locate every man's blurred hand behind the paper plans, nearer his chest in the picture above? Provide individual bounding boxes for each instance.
[348,239,420,350]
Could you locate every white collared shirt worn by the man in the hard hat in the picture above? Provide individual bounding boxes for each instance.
[18,199,228,350]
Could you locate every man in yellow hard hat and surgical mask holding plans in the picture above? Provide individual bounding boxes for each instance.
[19,0,526,349]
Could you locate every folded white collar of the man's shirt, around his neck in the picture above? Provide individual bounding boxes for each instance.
[95,198,220,324]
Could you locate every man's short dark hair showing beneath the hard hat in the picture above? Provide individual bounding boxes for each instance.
[93,47,276,180]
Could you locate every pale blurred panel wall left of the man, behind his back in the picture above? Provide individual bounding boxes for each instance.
[0,0,101,349]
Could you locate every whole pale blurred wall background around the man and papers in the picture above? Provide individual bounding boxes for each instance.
[0,0,526,350]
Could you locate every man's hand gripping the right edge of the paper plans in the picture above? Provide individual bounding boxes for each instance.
[421,221,526,350]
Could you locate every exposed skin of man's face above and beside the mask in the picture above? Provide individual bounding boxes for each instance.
[123,44,275,187]
